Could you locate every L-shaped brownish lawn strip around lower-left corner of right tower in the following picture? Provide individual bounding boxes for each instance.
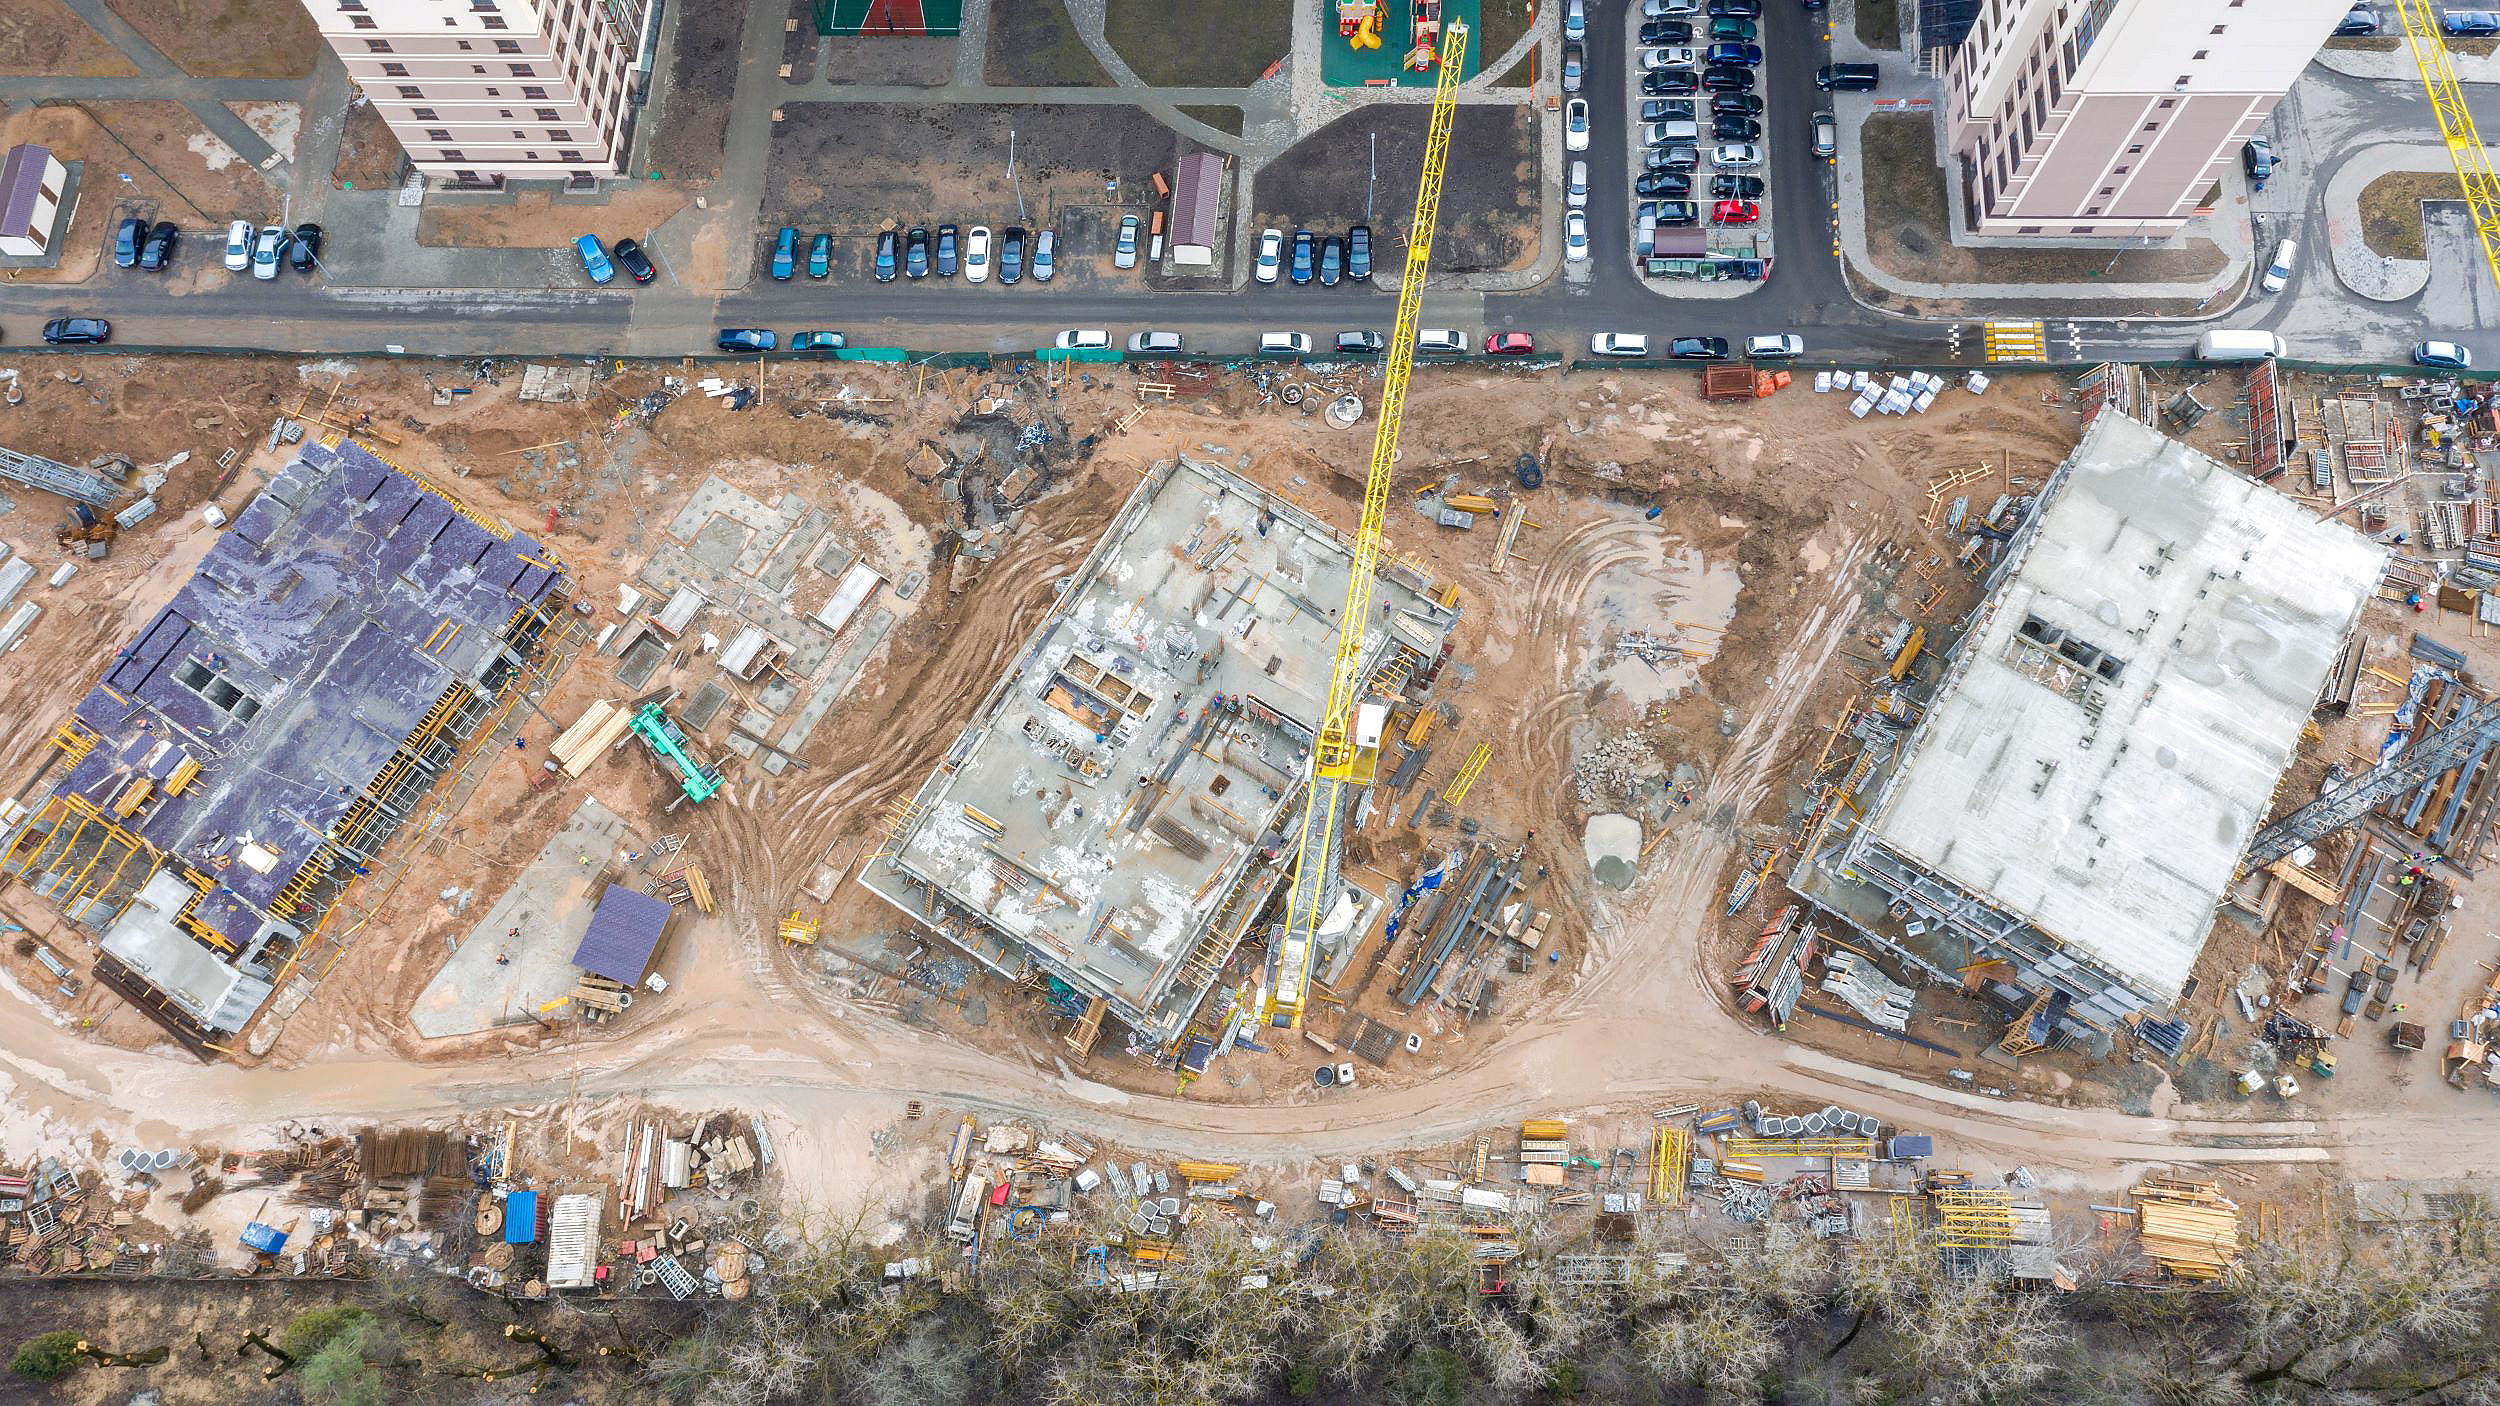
[1858,113,2228,285]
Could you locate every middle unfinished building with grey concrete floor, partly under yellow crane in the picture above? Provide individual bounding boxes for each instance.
[860,460,1458,1051]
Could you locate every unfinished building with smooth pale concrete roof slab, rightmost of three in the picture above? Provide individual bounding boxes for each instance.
[1793,413,2388,1053]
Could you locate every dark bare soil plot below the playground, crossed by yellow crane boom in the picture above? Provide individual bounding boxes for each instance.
[1250,103,1538,273]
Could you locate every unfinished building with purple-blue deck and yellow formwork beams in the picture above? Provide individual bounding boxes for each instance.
[0,443,563,1053]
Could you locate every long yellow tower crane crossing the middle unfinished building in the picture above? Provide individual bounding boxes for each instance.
[1268,23,1468,1026]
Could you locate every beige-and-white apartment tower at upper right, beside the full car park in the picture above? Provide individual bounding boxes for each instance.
[1945,0,2350,238]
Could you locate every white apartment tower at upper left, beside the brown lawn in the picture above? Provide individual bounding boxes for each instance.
[305,0,653,185]
